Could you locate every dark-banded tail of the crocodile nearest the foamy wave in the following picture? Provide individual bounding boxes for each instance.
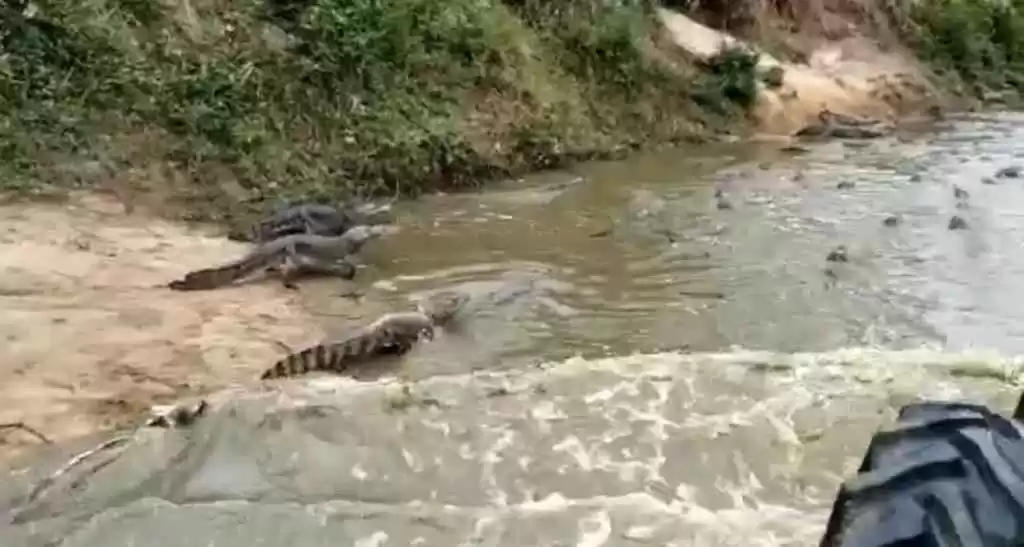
[259,332,412,380]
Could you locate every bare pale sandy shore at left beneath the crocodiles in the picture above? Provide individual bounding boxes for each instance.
[0,196,344,459]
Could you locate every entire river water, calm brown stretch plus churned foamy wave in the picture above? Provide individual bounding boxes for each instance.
[9,114,1024,547]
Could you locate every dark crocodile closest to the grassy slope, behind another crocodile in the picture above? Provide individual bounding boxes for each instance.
[227,202,393,243]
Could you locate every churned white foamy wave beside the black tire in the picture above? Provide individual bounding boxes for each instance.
[3,348,1024,547]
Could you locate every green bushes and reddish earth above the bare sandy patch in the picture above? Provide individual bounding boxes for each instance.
[663,0,1024,97]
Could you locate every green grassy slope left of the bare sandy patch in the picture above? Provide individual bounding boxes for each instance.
[0,0,754,225]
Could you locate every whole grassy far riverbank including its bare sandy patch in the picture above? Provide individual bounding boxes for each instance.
[0,0,1024,220]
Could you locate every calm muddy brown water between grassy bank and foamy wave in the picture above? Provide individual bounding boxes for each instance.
[309,116,1024,367]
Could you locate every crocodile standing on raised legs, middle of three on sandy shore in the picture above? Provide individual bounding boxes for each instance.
[168,225,389,291]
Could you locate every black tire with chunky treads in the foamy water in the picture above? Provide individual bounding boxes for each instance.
[820,403,1024,547]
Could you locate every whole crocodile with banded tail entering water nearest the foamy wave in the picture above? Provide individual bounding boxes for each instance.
[260,291,469,380]
